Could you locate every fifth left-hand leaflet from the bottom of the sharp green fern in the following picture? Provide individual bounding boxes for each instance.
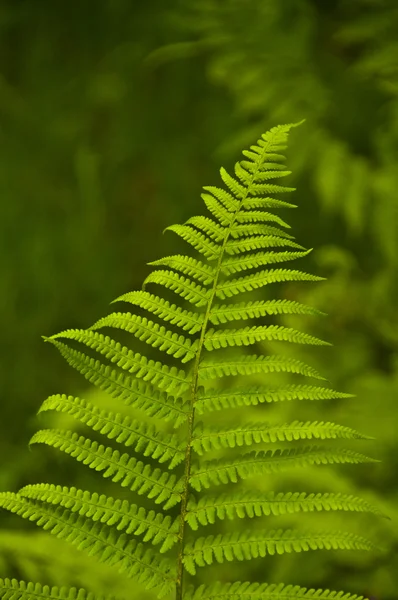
[39,394,185,469]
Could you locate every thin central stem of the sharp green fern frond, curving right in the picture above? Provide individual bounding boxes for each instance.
[175,144,268,600]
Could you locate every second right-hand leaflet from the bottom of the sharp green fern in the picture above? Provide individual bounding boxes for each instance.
[183,529,375,575]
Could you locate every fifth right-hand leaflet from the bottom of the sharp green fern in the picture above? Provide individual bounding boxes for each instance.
[191,421,374,455]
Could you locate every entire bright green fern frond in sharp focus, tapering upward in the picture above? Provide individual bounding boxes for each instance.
[0,124,386,600]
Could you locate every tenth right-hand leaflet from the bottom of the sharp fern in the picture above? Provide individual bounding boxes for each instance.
[217,269,325,300]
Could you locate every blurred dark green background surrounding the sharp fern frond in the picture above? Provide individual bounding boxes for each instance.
[0,0,398,600]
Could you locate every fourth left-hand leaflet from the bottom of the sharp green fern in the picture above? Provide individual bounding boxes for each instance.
[29,429,182,508]
